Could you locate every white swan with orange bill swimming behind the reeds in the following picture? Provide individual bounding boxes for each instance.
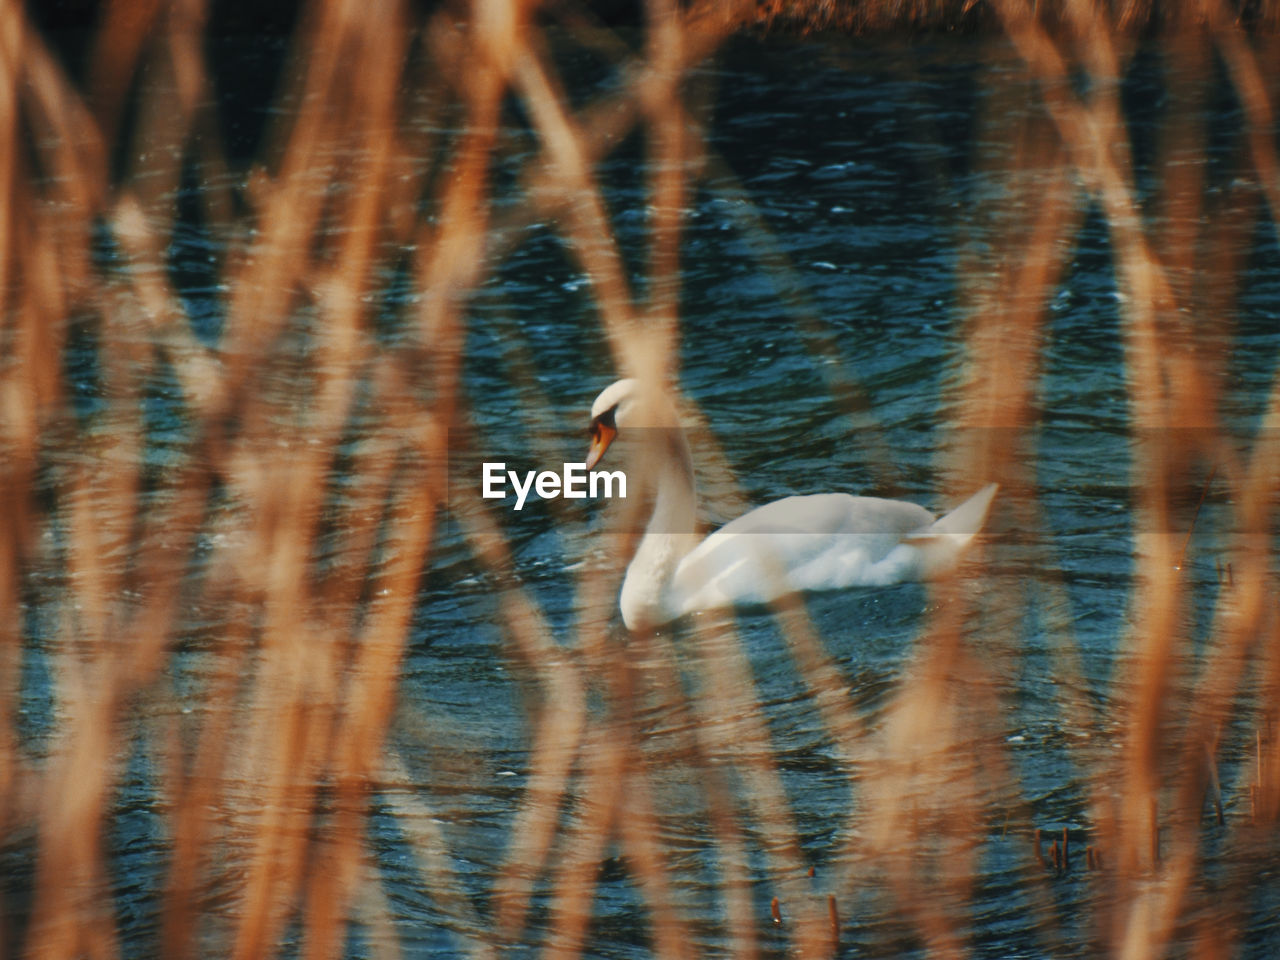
[586,379,997,630]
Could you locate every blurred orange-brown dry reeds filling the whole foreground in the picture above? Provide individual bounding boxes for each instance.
[0,0,1280,959]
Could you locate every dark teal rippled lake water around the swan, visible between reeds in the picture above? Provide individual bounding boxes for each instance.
[10,20,1280,957]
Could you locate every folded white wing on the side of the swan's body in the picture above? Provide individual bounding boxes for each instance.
[671,493,933,612]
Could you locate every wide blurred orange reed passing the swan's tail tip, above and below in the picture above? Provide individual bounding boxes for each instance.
[850,58,1091,931]
